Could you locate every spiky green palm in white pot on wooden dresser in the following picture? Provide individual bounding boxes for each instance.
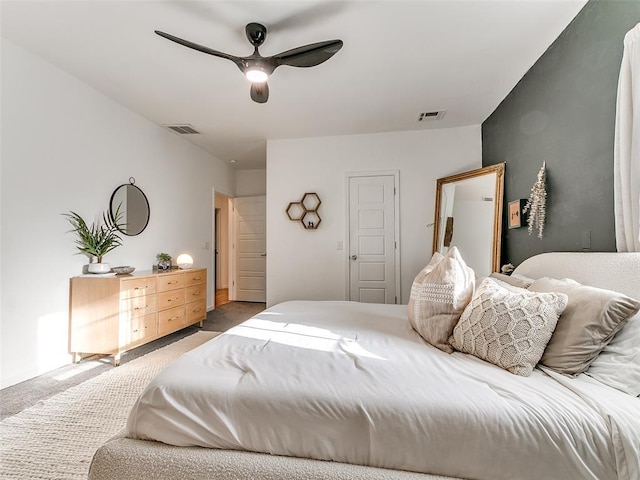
[63,207,124,273]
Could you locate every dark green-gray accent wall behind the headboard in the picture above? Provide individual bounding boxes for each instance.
[482,0,640,265]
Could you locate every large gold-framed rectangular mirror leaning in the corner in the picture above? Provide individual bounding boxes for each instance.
[433,163,504,277]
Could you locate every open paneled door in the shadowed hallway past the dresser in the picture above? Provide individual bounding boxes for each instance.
[234,196,267,302]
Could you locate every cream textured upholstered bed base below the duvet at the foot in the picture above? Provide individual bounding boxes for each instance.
[88,437,460,480]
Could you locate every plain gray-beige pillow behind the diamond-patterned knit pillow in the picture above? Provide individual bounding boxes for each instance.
[529,278,640,375]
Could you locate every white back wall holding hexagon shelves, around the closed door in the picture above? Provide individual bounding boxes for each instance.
[267,125,482,306]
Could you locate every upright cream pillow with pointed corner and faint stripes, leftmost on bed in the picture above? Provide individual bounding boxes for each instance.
[409,247,475,353]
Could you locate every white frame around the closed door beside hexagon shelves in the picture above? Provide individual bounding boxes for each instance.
[344,170,402,303]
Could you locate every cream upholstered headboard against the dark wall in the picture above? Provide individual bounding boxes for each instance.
[514,252,640,299]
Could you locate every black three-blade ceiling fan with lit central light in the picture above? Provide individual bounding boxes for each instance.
[155,23,342,103]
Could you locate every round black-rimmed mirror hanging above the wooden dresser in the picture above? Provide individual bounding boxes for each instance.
[109,177,150,236]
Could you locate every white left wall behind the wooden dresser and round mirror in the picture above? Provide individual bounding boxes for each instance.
[0,39,235,387]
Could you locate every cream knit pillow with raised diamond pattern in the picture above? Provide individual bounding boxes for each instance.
[449,278,567,377]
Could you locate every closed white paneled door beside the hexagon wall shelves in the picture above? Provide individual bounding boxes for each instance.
[348,175,398,303]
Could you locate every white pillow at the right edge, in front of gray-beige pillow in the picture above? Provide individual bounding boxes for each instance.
[586,314,640,397]
